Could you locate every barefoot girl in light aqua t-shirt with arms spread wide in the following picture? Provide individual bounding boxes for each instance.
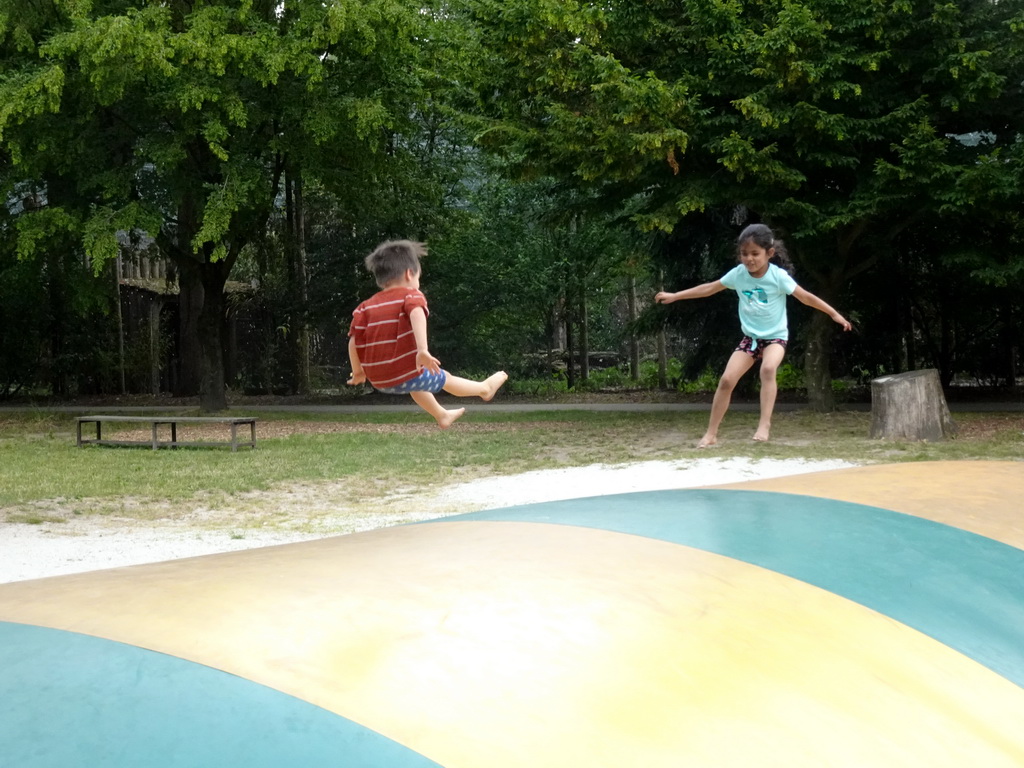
[654,224,853,449]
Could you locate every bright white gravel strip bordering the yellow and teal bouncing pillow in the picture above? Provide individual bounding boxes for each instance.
[0,458,855,583]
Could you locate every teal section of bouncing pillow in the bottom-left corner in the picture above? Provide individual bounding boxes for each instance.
[0,622,436,768]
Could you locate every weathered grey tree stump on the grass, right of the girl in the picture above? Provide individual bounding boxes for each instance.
[871,368,956,442]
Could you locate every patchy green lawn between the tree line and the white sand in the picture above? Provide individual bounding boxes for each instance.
[0,408,1024,522]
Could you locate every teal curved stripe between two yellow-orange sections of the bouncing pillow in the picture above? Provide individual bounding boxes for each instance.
[432,489,1024,687]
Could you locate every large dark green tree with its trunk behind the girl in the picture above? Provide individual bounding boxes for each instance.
[464,0,1024,409]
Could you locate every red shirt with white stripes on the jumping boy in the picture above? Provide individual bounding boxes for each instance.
[348,288,430,387]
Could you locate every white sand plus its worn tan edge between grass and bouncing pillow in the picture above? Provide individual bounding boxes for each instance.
[0,458,854,582]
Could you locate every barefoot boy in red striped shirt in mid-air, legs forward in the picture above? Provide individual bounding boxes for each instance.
[348,240,508,429]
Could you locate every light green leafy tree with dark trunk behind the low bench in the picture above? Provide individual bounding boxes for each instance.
[0,0,446,411]
